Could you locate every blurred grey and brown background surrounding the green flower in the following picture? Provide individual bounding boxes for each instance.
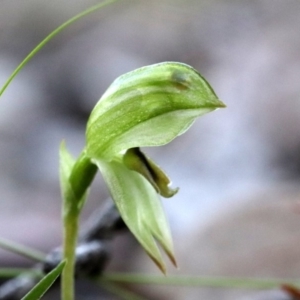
[0,0,300,300]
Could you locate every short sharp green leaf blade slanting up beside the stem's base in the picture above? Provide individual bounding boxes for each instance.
[21,261,65,300]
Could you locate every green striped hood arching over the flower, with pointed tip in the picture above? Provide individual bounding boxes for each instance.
[86,62,225,160]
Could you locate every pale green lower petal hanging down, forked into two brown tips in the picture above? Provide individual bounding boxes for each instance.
[94,160,176,273]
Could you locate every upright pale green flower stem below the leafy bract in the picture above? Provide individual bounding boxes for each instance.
[61,209,79,300]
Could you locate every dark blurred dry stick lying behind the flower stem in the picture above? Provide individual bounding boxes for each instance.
[0,202,127,300]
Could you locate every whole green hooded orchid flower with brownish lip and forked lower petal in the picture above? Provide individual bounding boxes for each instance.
[84,62,225,272]
